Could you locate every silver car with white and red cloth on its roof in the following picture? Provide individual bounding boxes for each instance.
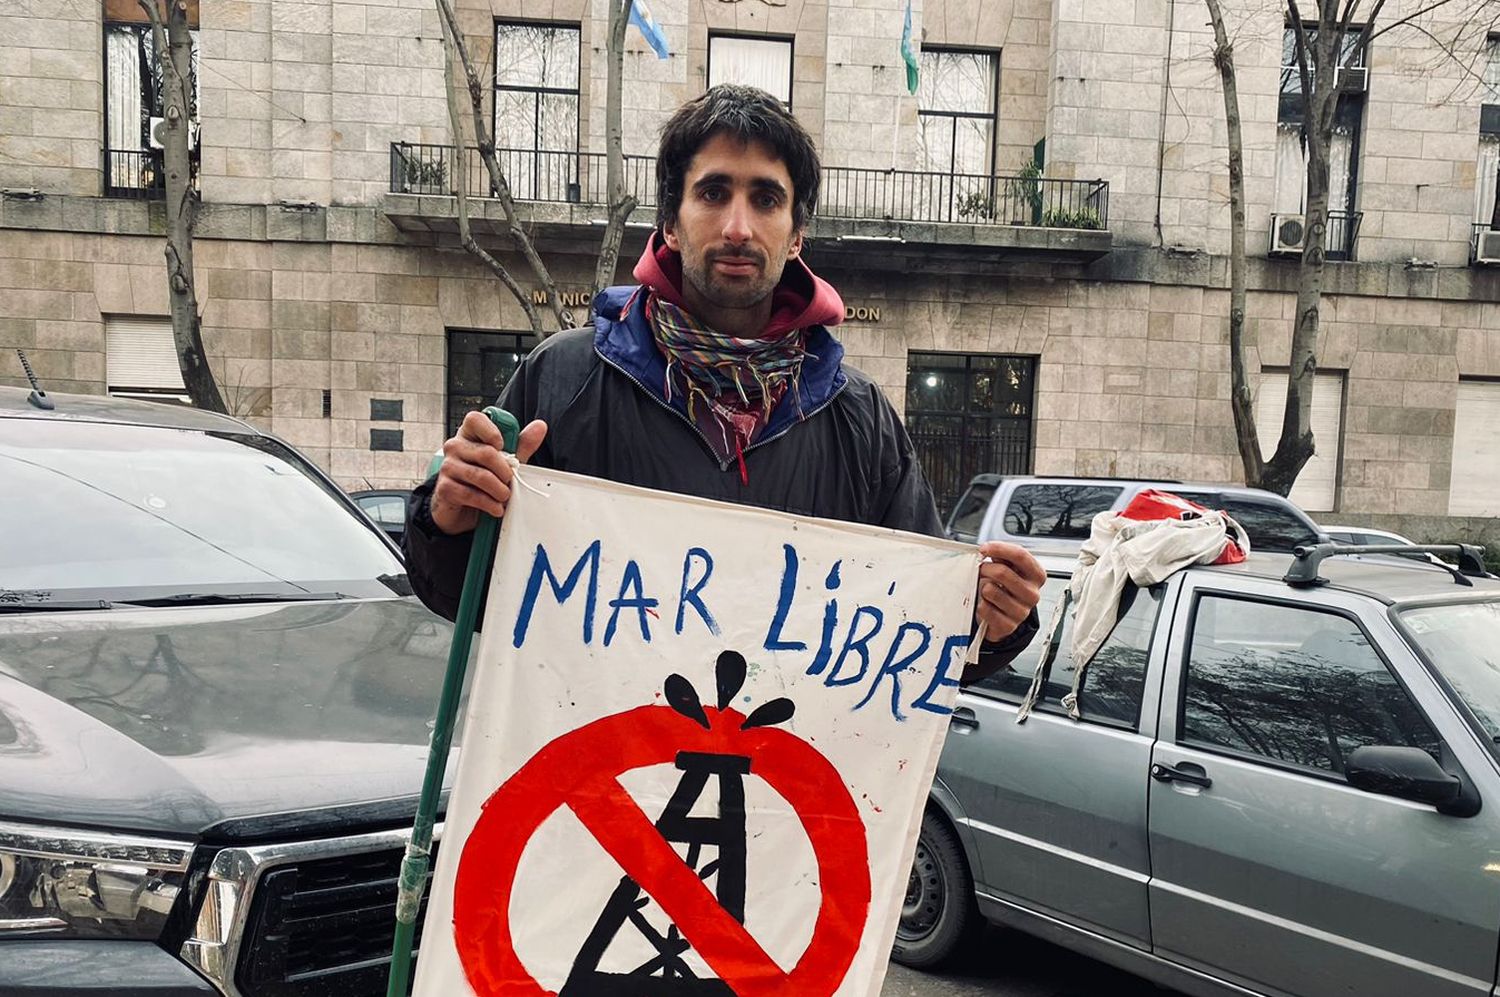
[894,544,1500,997]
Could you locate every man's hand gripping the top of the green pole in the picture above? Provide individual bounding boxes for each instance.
[432,412,548,535]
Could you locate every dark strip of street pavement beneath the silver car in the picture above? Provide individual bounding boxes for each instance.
[881,928,1181,997]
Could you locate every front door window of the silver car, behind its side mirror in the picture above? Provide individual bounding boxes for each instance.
[1179,595,1439,774]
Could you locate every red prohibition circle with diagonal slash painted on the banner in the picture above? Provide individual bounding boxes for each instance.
[453,706,870,997]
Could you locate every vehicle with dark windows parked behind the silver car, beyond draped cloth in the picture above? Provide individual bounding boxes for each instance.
[948,474,1325,552]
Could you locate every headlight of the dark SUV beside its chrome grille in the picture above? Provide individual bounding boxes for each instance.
[0,823,192,939]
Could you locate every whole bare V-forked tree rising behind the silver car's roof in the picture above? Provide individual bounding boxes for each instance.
[1205,0,1494,495]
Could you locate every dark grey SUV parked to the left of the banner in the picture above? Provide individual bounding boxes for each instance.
[0,387,450,997]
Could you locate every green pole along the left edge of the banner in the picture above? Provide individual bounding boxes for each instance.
[386,405,521,997]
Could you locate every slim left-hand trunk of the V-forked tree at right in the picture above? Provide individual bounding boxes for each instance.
[1200,0,1266,487]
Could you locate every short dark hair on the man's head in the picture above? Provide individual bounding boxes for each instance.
[657,82,822,228]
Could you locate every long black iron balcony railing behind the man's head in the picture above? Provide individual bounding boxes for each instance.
[390,142,1110,229]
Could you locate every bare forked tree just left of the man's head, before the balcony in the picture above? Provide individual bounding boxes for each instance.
[437,0,636,337]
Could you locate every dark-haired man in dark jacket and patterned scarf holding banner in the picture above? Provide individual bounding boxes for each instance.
[405,85,1046,681]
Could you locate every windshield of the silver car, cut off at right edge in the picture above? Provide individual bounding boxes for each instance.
[1401,600,1500,744]
